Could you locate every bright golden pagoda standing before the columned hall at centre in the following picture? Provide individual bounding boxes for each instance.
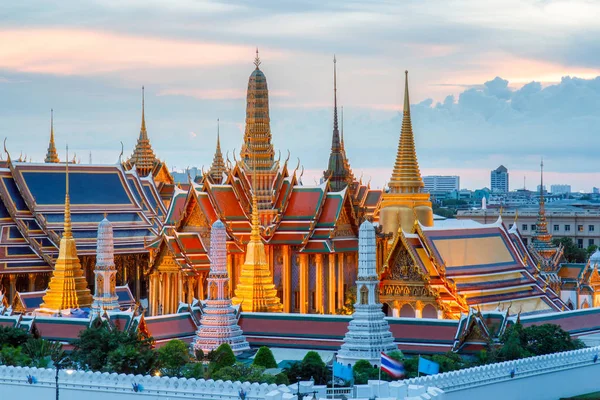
[232,148,283,312]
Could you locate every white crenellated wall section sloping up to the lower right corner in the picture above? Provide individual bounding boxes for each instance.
[407,347,600,400]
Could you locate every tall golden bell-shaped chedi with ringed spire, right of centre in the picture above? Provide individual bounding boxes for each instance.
[380,71,433,235]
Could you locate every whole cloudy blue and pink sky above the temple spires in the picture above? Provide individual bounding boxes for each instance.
[0,0,600,191]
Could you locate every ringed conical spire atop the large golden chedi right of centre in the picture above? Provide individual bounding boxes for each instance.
[389,71,425,193]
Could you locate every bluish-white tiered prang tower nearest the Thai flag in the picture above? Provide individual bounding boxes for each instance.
[338,221,398,365]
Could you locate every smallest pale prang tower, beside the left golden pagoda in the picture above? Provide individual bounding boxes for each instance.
[92,217,119,311]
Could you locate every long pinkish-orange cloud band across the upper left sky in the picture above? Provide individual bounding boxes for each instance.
[0,29,282,75]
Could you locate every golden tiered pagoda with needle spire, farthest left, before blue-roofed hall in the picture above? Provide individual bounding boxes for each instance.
[39,148,93,312]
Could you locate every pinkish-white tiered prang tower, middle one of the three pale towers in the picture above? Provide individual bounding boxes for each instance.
[192,220,250,355]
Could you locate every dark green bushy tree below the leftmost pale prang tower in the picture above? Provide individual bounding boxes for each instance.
[70,320,155,374]
